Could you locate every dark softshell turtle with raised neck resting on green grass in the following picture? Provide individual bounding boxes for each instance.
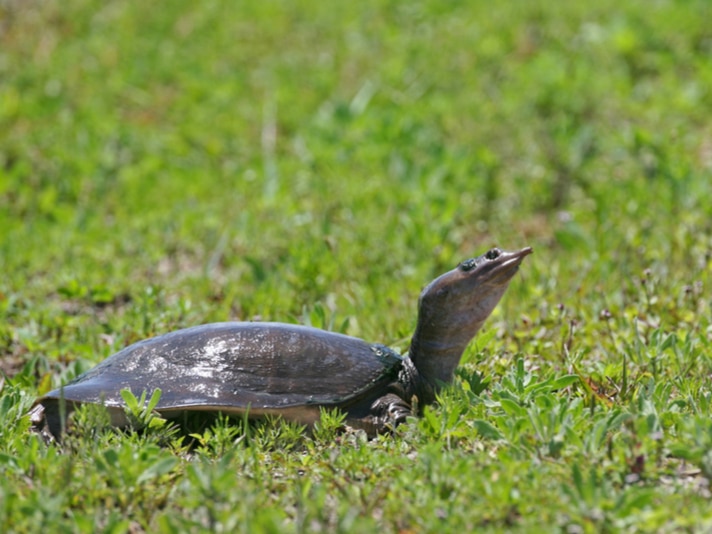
[31,247,532,436]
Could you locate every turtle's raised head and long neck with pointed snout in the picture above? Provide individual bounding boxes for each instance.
[410,247,532,392]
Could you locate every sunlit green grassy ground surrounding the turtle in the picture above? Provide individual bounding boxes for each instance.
[0,0,712,533]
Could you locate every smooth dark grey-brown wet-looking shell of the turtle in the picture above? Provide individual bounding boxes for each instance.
[38,323,402,432]
